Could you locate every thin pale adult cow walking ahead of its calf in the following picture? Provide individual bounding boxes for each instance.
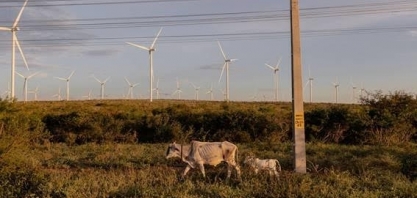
[166,141,240,179]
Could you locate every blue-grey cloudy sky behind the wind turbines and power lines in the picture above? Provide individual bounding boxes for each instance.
[0,0,417,103]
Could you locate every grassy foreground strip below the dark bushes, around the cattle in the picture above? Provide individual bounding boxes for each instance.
[0,142,417,198]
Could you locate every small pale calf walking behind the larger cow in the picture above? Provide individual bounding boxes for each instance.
[244,156,281,178]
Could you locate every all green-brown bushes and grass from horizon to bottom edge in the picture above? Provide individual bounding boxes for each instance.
[0,92,417,197]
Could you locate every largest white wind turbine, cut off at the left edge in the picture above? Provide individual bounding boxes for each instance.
[0,0,29,98]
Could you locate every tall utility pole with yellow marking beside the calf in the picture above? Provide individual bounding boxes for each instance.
[290,0,307,173]
